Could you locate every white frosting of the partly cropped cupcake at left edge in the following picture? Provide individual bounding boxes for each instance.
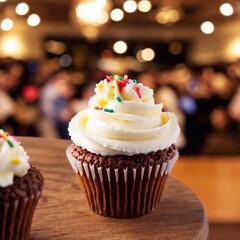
[0,129,30,187]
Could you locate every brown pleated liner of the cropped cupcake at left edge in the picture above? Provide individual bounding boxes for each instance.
[0,191,41,240]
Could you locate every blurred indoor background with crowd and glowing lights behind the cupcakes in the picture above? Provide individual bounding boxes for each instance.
[0,0,240,155]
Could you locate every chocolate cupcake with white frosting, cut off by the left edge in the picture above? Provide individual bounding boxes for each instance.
[0,130,43,240]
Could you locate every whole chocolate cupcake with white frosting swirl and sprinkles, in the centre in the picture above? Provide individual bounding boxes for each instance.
[66,75,180,218]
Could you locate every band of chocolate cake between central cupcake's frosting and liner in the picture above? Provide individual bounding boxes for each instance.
[71,144,178,169]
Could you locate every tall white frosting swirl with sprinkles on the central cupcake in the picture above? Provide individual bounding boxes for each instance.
[69,76,180,155]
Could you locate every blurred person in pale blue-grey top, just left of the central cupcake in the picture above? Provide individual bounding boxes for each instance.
[39,70,75,139]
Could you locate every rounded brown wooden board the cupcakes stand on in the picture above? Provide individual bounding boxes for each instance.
[19,137,208,240]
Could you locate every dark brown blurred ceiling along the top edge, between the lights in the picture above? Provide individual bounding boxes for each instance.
[0,0,240,27]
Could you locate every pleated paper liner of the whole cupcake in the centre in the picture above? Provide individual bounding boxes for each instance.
[66,147,178,218]
